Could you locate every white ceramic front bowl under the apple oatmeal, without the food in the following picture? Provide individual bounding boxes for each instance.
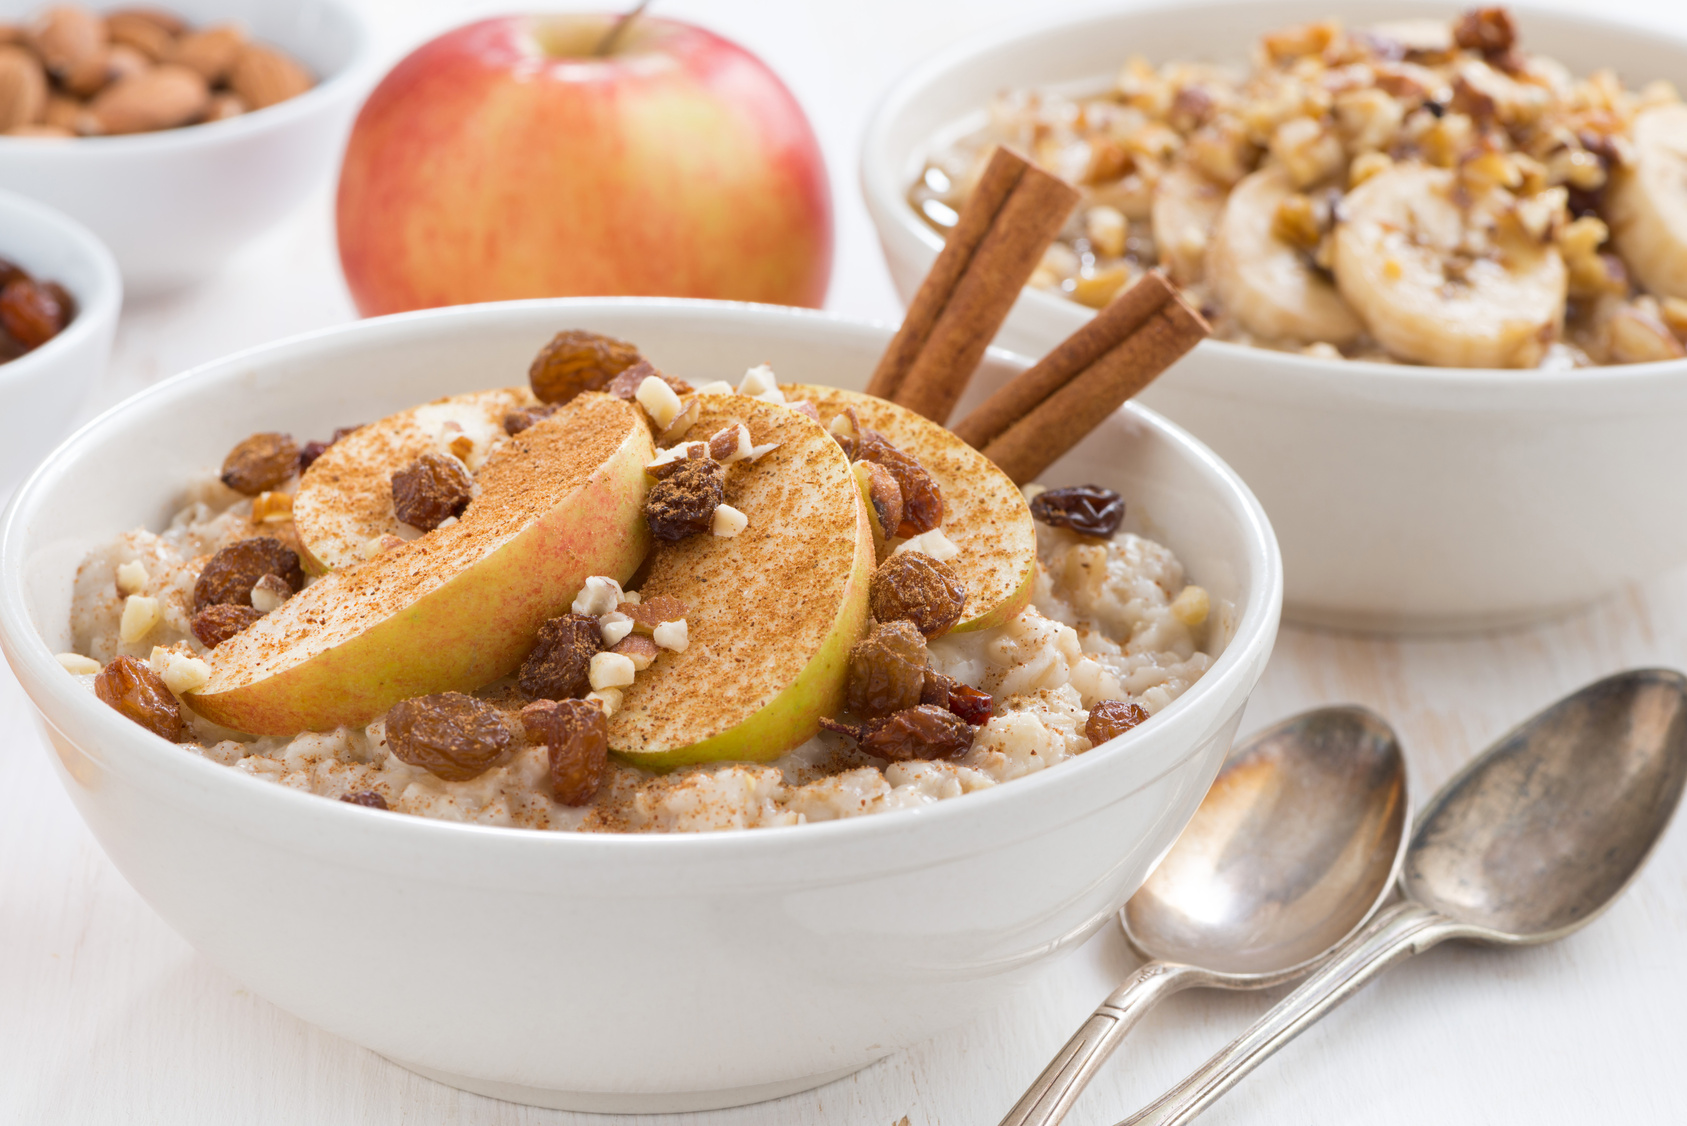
[0,299,1280,1111]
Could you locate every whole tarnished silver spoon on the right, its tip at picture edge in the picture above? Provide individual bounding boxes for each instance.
[1120,669,1687,1126]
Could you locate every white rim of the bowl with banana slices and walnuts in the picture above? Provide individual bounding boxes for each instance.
[860,0,1687,393]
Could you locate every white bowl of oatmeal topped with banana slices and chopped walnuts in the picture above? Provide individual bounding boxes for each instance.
[862,0,1687,631]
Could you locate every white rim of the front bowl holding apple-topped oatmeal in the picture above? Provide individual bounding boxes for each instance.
[0,297,1282,856]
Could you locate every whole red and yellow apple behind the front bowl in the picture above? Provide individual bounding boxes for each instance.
[337,15,832,316]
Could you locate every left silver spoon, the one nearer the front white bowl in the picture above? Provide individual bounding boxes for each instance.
[1002,707,1412,1126]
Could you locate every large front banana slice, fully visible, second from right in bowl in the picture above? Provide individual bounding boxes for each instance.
[1334,164,1567,368]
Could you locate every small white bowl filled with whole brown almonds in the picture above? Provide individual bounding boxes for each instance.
[0,0,371,292]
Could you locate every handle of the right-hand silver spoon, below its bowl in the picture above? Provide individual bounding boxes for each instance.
[1118,901,1461,1126]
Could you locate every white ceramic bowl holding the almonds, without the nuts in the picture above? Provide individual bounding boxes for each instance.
[0,0,375,294]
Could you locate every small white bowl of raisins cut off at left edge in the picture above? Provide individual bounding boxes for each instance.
[0,192,123,495]
